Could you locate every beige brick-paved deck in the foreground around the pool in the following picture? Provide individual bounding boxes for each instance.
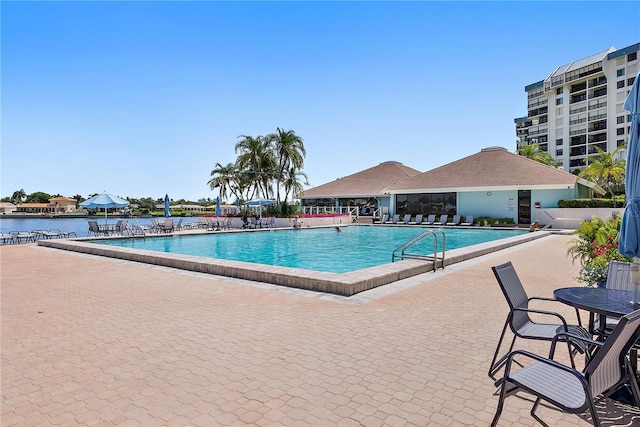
[0,235,633,427]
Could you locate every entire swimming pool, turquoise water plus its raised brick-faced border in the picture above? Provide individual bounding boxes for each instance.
[37,225,551,297]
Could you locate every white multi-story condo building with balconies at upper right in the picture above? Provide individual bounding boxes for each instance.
[514,43,640,172]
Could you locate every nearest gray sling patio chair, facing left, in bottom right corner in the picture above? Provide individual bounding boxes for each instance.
[491,310,640,426]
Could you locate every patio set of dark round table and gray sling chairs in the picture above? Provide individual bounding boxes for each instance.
[489,261,640,426]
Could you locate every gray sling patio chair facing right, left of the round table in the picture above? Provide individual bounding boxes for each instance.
[489,262,591,378]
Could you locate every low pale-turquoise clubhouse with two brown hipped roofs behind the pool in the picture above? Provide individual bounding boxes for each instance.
[300,147,604,224]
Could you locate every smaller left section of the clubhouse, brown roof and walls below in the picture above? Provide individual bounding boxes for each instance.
[298,161,421,213]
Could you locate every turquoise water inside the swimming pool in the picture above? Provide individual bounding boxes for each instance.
[96,226,526,273]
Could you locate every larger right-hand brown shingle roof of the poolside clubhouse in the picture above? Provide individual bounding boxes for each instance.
[387,147,578,193]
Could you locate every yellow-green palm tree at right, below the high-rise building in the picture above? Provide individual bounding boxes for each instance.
[579,144,627,207]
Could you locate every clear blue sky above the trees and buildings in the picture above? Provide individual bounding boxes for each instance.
[0,1,640,200]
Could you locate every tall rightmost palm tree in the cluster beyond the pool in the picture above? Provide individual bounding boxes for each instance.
[267,128,307,202]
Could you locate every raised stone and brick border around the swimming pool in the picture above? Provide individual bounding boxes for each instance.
[37,227,553,297]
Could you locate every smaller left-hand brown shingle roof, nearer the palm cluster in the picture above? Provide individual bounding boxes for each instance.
[298,161,421,199]
